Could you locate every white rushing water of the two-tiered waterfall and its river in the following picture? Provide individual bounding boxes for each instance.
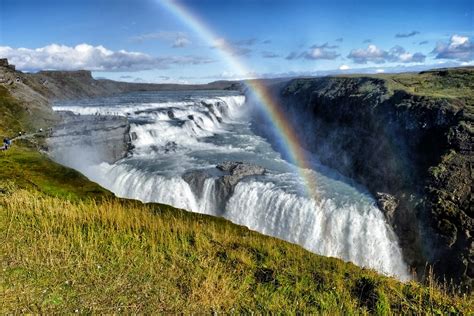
[54,91,408,279]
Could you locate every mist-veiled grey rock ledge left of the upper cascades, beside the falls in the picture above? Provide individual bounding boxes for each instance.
[46,112,131,164]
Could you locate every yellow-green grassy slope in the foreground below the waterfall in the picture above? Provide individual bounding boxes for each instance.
[0,80,473,314]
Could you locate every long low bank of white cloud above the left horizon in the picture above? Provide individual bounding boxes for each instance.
[0,44,212,71]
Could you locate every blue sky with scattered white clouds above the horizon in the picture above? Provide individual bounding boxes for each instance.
[0,0,474,83]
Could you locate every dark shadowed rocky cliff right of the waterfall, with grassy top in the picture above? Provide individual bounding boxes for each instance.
[274,69,474,287]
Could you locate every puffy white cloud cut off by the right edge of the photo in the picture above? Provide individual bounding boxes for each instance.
[432,34,474,61]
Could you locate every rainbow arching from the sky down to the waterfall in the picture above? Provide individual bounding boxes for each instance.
[158,0,317,198]
